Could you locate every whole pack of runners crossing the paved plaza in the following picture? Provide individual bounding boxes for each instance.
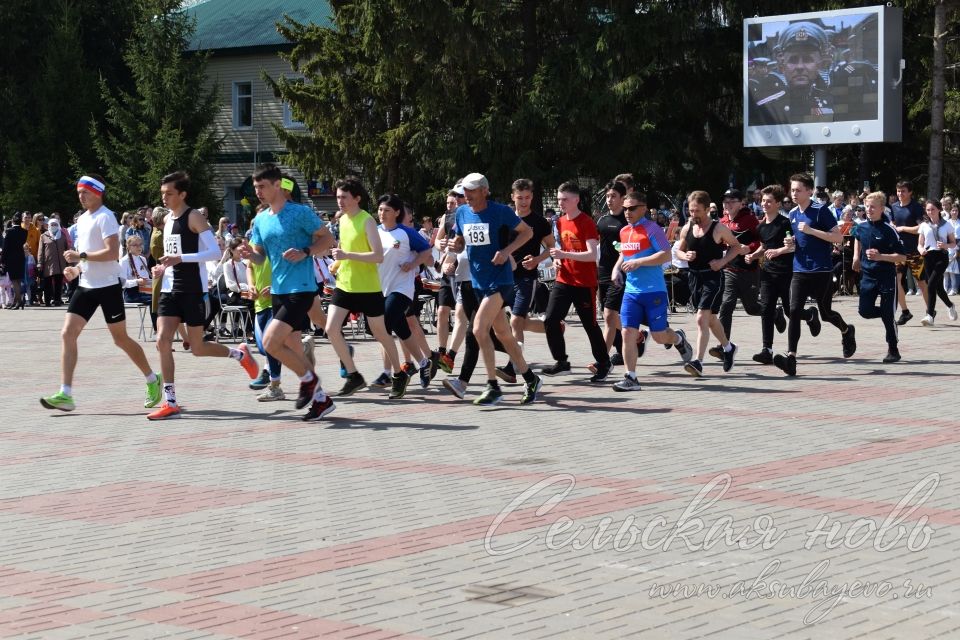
[41,165,956,421]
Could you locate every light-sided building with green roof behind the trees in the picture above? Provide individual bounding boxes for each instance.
[185,0,333,222]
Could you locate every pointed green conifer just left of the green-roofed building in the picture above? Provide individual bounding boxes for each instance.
[92,0,220,215]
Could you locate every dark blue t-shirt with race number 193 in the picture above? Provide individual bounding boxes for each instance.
[453,200,521,291]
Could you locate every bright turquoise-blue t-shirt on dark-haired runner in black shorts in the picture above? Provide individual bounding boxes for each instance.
[250,202,322,295]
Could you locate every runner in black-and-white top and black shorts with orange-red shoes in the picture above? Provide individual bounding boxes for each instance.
[147,171,260,420]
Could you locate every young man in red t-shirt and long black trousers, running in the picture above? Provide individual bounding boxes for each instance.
[542,182,611,382]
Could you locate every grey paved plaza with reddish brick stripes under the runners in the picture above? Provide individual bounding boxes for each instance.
[0,298,960,640]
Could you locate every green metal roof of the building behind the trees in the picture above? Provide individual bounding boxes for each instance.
[185,0,330,53]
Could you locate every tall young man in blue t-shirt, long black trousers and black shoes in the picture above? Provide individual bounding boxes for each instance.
[773,173,857,376]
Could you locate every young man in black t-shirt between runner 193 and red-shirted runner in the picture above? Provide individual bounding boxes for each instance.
[497,178,555,384]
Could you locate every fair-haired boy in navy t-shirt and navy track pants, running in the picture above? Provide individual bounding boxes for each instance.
[852,191,906,364]
